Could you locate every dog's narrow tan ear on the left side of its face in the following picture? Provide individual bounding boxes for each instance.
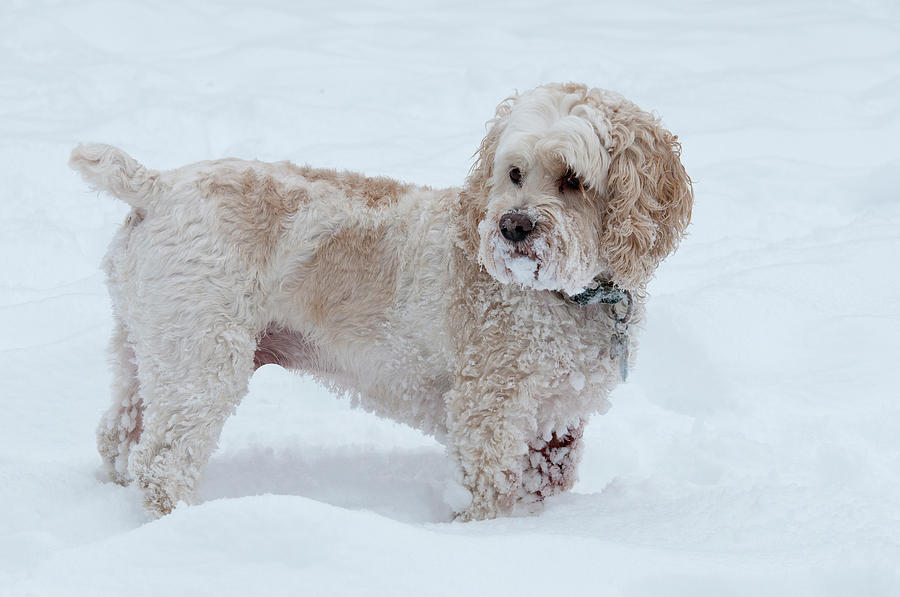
[457,96,518,259]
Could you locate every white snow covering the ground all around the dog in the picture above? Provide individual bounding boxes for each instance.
[0,0,900,597]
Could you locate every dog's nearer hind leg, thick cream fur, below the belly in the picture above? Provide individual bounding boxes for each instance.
[128,306,256,515]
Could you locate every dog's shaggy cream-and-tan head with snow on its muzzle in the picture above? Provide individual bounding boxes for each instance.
[460,84,693,295]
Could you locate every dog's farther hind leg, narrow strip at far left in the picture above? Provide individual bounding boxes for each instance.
[97,321,143,485]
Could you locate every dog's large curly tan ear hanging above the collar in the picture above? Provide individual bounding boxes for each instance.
[600,99,694,289]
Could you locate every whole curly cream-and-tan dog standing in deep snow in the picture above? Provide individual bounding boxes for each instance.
[70,84,693,520]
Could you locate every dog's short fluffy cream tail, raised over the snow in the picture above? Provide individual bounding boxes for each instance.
[69,143,167,209]
